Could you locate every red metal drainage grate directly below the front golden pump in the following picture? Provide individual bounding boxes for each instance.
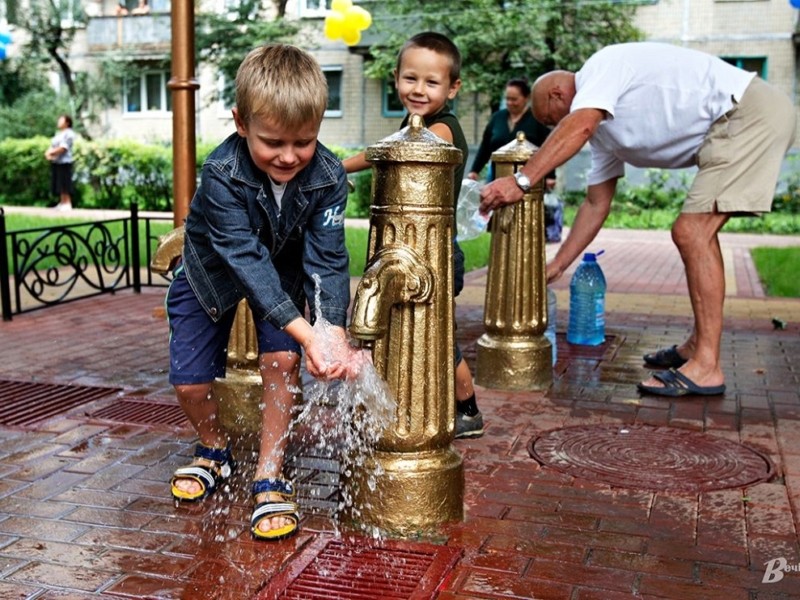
[253,537,463,600]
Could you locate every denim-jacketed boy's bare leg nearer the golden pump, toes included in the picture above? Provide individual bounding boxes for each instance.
[255,351,300,531]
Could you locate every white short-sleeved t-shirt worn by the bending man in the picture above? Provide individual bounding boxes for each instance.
[570,42,755,185]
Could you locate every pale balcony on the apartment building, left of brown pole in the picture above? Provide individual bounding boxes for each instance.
[86,12,172,56]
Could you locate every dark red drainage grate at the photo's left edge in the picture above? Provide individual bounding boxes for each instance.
[0,380,121,427]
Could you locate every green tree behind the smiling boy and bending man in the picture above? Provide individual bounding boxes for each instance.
[367,0,644,110]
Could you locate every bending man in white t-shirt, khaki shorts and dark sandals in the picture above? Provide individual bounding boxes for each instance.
[481,42,795,396]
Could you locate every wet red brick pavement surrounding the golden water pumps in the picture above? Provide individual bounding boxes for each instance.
[0,223,800,600]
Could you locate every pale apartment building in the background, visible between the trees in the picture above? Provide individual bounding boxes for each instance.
[1,0,800,155]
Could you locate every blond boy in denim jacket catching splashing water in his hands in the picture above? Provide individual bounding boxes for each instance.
[166,44,352,539]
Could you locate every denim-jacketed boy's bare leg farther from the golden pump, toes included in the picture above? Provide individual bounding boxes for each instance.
[175,383,228,494]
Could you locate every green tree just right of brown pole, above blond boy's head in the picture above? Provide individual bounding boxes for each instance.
[195,0,299,104]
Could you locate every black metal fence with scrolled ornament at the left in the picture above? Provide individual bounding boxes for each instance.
[0,204,171,321]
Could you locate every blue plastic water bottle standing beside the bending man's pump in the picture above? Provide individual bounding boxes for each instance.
[567,250,606,346]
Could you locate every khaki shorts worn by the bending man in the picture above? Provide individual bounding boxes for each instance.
[682,77,796,213]
